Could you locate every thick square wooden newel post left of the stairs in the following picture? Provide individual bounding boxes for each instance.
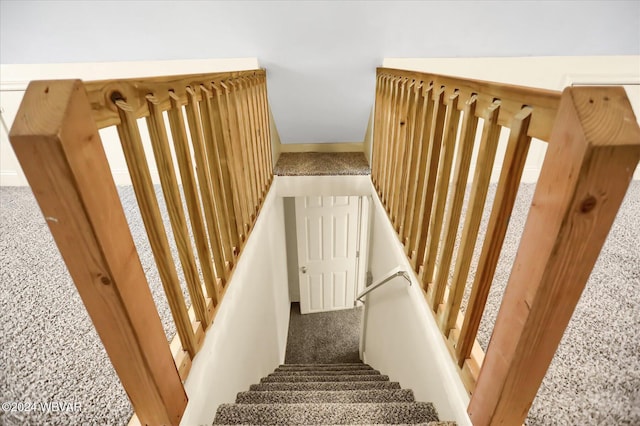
[9,80,187,425]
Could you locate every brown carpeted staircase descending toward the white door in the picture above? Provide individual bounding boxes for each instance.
[213,363,454,426]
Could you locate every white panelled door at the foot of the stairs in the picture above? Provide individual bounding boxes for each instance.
[296,196,359,314]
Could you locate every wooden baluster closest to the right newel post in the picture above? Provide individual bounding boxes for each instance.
[458,107,533,360]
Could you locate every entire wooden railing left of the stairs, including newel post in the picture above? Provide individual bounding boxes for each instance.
[10,70,273,424]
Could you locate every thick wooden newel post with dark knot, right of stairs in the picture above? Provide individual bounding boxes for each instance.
[468,87,640,425]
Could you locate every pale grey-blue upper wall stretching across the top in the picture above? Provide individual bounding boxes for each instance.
[0,0,640,143]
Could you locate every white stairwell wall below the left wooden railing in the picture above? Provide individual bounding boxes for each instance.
[182,183,290,425]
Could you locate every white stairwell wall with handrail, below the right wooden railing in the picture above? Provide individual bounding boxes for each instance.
[361,182,470,425]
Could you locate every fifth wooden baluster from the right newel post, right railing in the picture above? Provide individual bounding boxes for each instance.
[413,88,446,273]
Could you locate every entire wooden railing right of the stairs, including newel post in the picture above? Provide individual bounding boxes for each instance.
[372,68,640,425]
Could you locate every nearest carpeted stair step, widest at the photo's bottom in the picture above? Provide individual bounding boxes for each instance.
[213,402,438,425]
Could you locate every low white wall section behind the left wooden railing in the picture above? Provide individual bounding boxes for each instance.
[0,58,260,186]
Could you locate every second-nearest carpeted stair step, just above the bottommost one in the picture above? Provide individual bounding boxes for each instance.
[236,389,415,404]
